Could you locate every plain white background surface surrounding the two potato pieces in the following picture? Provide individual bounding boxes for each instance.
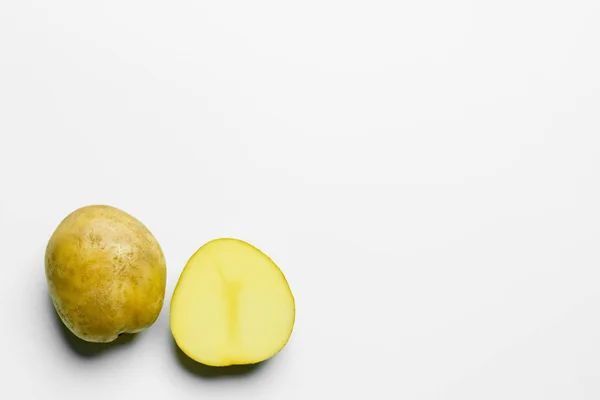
[0,0,600,400]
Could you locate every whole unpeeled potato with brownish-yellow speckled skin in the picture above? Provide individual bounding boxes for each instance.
[45,205,166,343]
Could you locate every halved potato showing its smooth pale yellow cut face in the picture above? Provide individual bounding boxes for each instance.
[170,239,295,366]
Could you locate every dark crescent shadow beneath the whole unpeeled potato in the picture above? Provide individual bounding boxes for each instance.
[47,296,137,358]
